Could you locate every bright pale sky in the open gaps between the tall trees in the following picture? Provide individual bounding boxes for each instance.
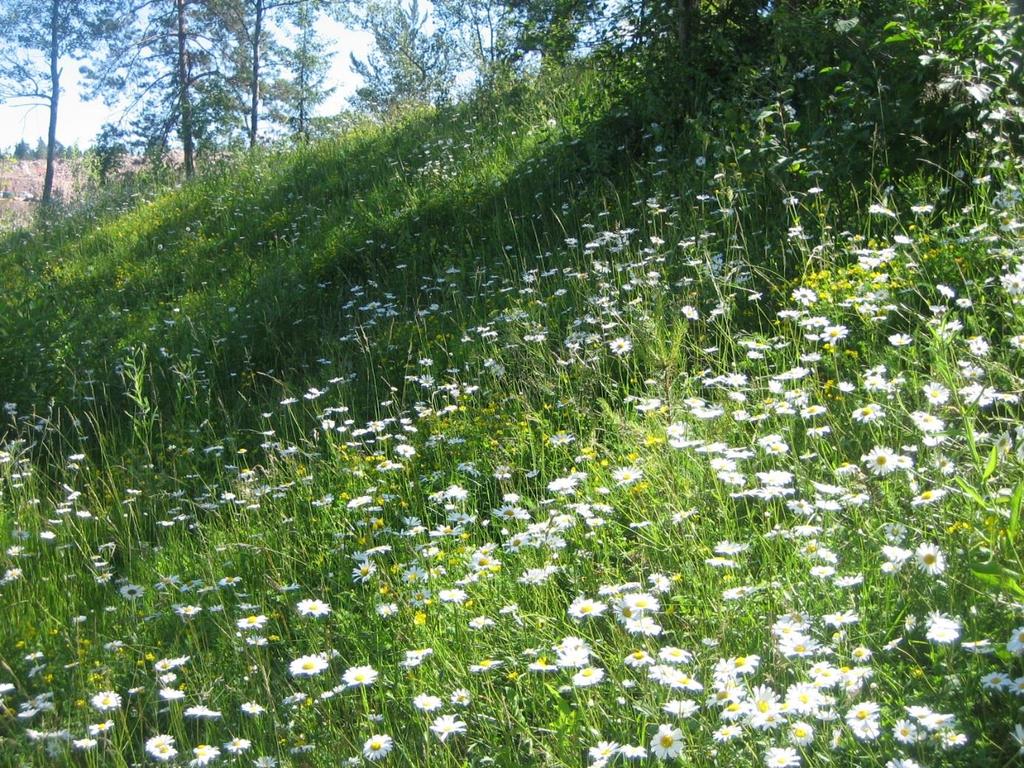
[0,17,371,148]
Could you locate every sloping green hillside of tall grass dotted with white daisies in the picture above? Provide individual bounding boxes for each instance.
[0,16,1024,768]
